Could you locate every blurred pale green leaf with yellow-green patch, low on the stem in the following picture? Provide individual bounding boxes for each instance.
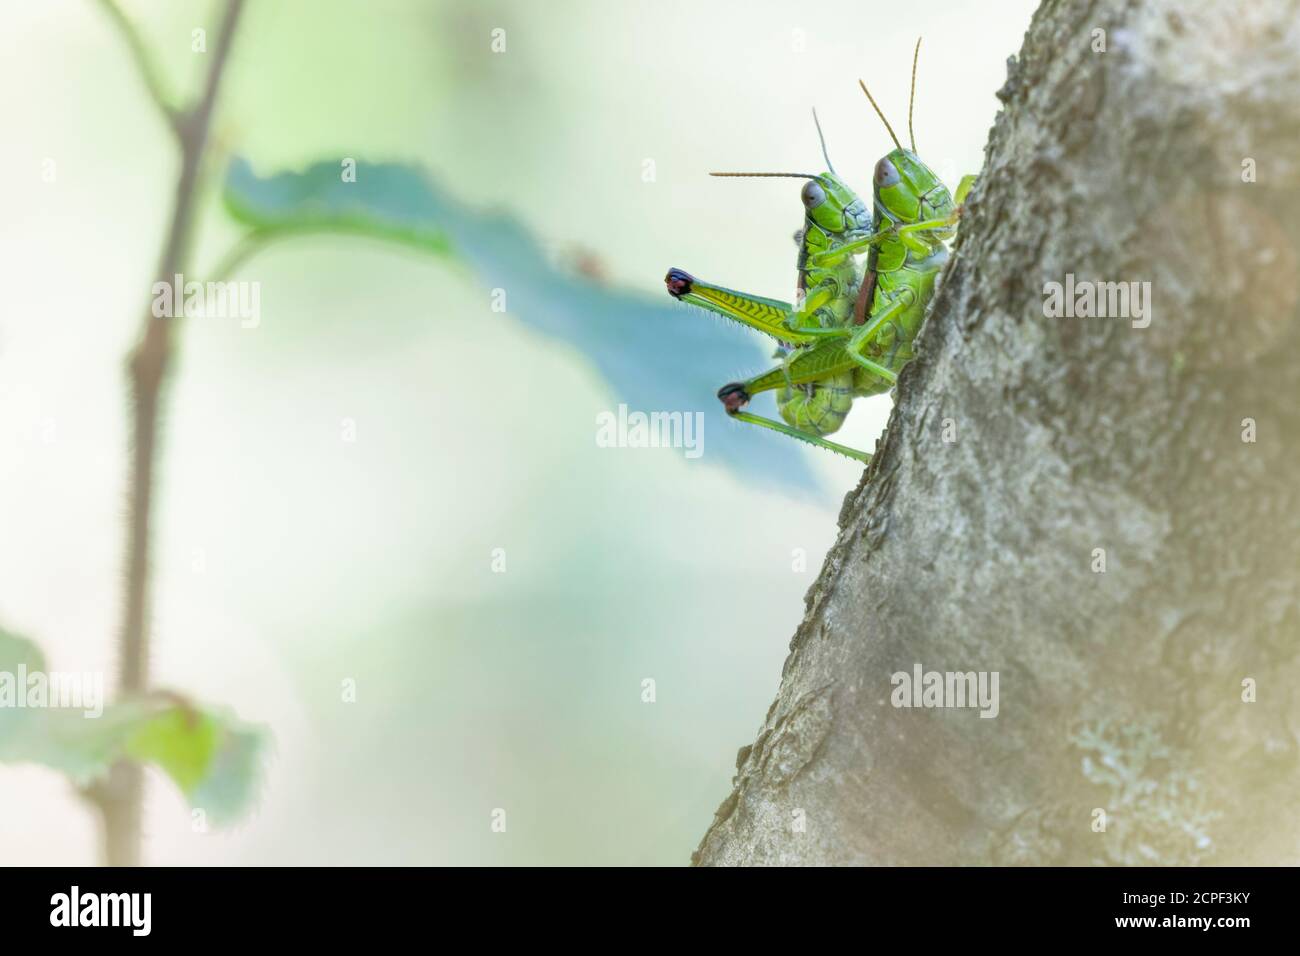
[0,631,265,823]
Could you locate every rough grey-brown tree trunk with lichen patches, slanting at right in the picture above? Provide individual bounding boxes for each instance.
[694,0,1300,865]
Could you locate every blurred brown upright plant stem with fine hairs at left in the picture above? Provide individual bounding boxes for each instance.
[99,0,244,866]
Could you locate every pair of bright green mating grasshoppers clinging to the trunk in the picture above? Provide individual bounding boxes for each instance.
[664,40,975,462]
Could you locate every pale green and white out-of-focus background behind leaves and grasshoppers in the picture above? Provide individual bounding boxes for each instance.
[0,0,1034,864]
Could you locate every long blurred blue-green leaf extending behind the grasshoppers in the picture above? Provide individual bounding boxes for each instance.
[215,157,824,502]
